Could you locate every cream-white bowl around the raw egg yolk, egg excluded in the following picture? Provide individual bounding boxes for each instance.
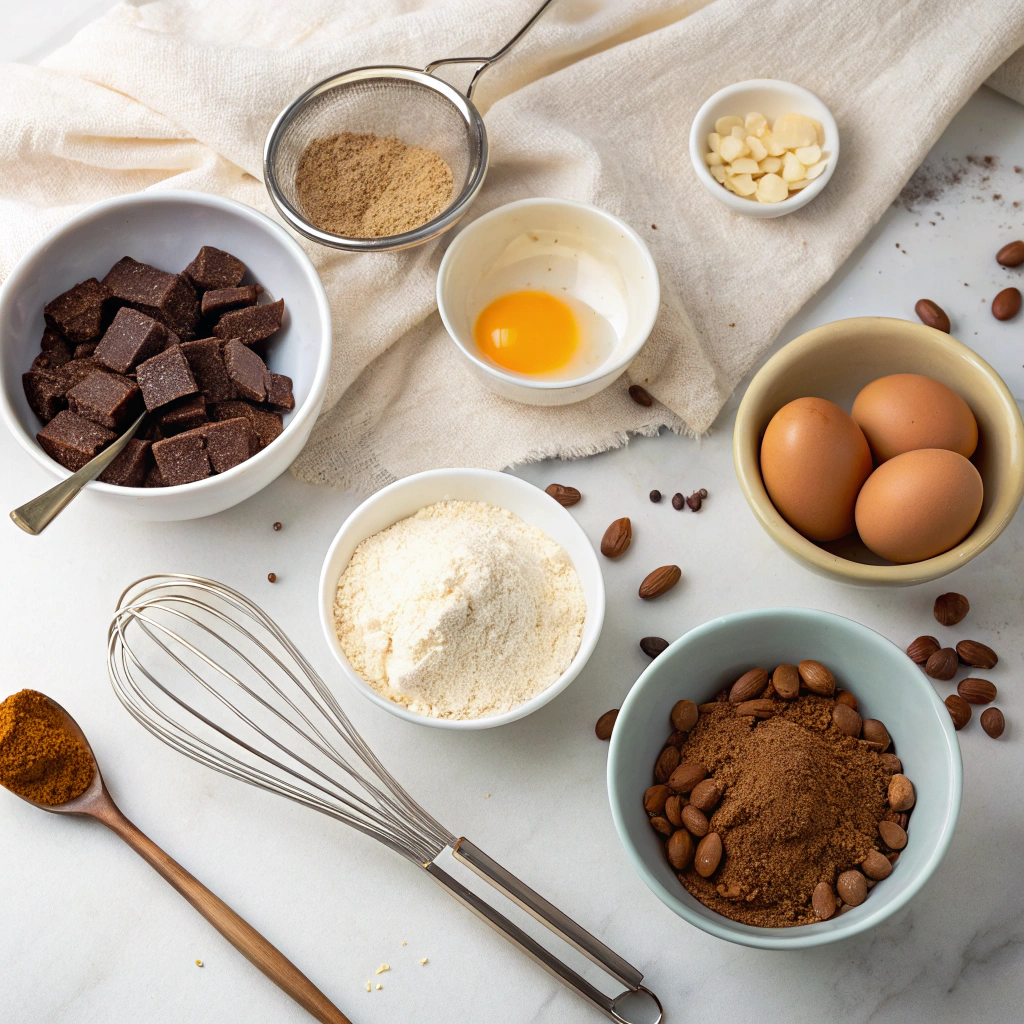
[437,199,660,406]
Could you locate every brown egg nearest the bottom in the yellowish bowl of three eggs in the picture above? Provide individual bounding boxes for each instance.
[857,449,984,563]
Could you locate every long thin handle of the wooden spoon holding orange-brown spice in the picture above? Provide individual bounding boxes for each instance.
[90,801,351,1024]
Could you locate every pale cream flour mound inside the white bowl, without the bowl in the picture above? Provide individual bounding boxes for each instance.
[334,501,587,719]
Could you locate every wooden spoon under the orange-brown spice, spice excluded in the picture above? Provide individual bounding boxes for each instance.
[7,697,351,1024]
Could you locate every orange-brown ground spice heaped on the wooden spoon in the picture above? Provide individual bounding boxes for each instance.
[0,690,94,807]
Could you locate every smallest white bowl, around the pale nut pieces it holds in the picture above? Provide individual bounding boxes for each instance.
[690,78,839,220]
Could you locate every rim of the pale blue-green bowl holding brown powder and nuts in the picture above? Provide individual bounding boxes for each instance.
[606,606,964,949]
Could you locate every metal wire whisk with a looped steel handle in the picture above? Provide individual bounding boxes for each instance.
[108,574,663,1024]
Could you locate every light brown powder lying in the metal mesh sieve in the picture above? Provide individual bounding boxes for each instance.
[295,131,455,239]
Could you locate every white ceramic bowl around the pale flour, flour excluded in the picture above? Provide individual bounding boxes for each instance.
[319,469,604,729]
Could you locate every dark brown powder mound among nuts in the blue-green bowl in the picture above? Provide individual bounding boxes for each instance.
[679,691,892,928]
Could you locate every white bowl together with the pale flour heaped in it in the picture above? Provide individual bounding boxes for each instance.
[319,469,604,729]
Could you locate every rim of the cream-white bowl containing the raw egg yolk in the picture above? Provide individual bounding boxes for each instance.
[435,197,662,391]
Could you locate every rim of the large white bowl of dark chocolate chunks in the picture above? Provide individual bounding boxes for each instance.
[0,188,333,502]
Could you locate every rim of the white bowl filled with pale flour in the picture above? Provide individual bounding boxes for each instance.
[317,468,605,731]
